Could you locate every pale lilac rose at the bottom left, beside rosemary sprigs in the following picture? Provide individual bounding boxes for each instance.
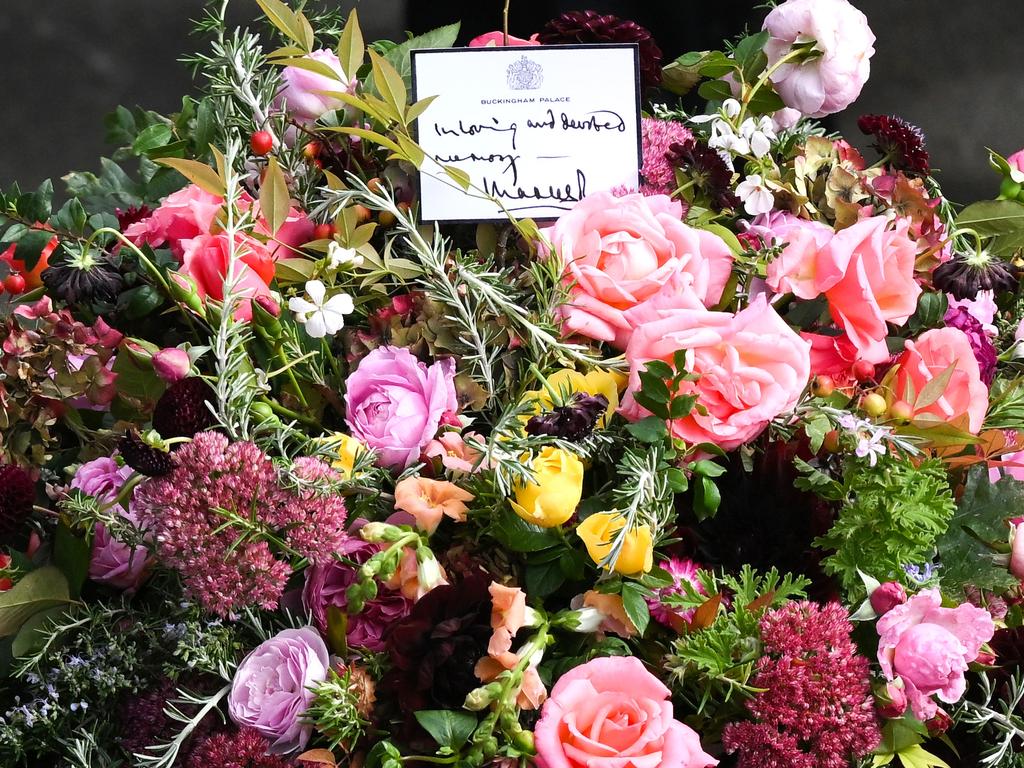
[227,627,331,755]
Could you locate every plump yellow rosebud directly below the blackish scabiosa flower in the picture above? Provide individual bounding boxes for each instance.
[512,445,583,528]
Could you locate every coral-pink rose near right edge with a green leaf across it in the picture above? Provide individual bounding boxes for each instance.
[892,328,988,434]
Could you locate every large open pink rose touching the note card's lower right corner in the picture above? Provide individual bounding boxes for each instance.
[544,191,732,349]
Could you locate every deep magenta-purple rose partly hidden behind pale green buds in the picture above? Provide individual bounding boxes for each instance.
[302,539,413,652]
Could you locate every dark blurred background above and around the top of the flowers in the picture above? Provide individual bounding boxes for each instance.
[0,0,1024,202]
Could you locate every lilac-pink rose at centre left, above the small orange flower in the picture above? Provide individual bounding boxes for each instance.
[345,347,459,469]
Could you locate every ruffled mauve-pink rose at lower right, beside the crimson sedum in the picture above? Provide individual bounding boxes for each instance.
[878,589,995,720]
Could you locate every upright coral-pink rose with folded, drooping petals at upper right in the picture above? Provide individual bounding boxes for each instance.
[814,216,921,364]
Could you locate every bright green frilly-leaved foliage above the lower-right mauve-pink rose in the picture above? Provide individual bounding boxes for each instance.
[796,454,955,600]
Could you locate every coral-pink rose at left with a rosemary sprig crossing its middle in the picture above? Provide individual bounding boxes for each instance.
[180,233,274,321]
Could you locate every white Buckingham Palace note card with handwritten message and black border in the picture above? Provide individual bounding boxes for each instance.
[413,44,641,221]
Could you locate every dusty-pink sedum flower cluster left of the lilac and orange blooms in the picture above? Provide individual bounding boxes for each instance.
[135,432,346,615]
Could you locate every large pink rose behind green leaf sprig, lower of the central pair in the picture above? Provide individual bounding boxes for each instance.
[622,295,811,451]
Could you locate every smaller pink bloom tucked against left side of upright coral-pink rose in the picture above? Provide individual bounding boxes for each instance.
[748,212,835,299]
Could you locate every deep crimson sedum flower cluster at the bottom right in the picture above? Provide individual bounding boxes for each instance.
[722,602,881,768]
